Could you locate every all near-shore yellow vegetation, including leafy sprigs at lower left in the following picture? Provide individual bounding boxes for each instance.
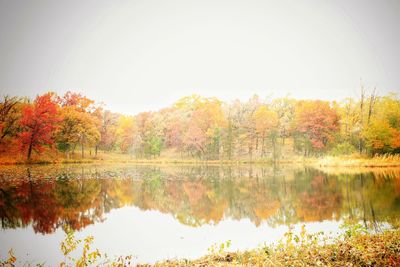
[0,225,400,267]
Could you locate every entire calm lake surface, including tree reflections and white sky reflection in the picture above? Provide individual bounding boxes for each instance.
[0,165,400,265]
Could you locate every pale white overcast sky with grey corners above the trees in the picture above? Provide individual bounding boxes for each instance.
[0,0,400,114]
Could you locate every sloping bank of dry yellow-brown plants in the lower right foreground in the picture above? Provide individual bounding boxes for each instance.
[145,230,400,267]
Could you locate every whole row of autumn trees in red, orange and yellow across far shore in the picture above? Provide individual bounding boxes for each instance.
[0,89,400,160]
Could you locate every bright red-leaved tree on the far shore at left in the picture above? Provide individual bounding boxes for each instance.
[19,93,59,160]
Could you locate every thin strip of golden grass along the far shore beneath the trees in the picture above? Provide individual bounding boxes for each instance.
[0,152,400,168]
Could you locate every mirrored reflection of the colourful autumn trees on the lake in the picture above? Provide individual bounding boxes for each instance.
[0,165,400,234]
